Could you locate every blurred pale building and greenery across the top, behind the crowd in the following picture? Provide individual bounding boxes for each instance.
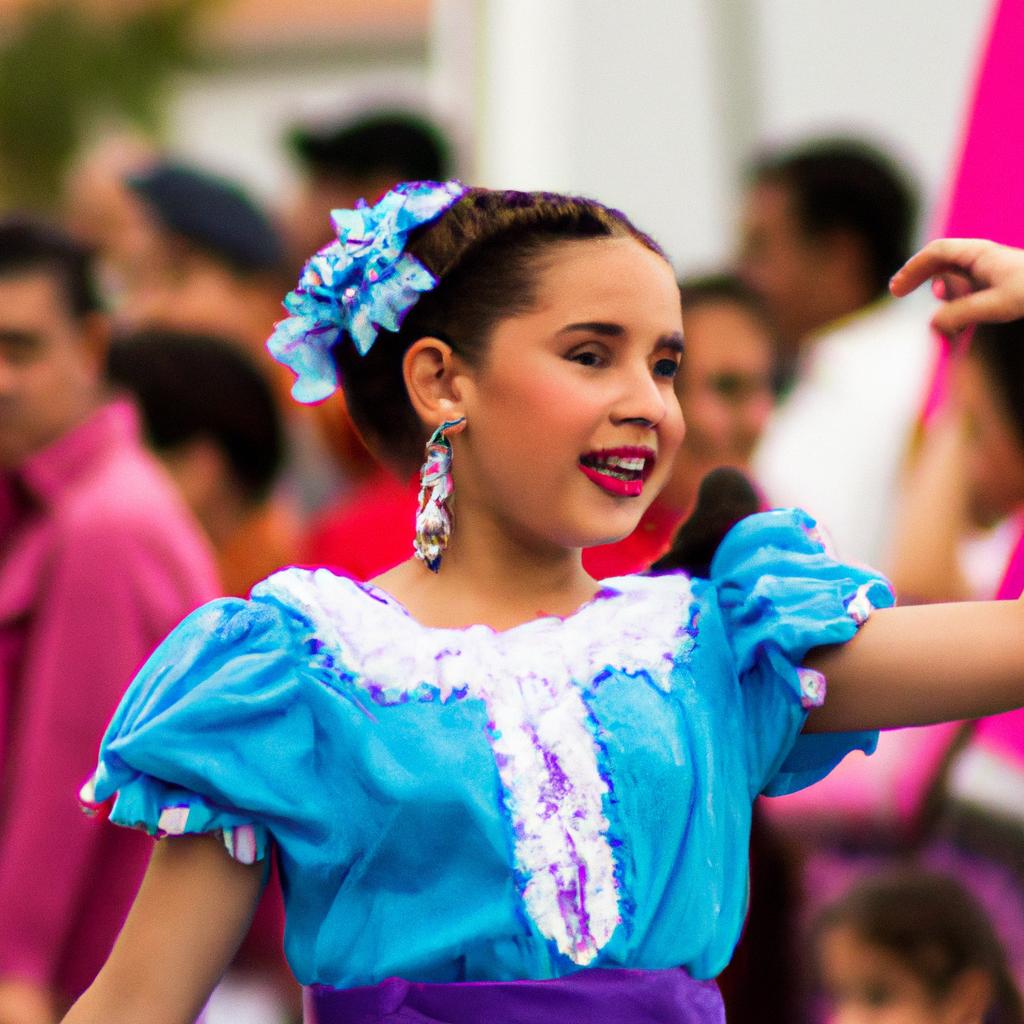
[0,0,991,270]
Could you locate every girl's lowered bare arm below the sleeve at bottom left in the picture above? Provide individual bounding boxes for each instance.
[65,836,263,1024]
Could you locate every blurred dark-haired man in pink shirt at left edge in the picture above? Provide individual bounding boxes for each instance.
[0,219,218,1024]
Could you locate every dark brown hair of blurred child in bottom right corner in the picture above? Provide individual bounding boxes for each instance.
[816,868,1024,1024]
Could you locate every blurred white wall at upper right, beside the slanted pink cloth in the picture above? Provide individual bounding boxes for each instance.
[754,0,992,228]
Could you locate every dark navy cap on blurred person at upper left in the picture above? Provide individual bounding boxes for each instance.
[126,161,284,271]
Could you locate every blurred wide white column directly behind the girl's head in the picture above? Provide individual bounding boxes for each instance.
[425,0,750,269]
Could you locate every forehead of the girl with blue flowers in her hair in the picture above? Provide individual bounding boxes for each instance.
[534,238,681,330]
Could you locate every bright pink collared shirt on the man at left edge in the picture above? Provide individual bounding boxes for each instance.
[0,400,219,997]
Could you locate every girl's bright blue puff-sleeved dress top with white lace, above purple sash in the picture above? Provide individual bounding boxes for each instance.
[83,511,892,988]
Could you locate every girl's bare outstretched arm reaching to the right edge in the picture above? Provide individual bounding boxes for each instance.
[805,601,1024,732]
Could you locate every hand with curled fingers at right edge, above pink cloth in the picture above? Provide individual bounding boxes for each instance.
[889,239,1024,335]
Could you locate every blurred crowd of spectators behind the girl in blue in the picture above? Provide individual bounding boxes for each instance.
[0,96,1024,1024]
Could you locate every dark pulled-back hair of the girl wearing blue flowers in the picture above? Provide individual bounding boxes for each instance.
[333,188,665,471]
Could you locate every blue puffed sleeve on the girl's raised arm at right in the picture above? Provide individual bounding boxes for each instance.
[710,510,894,796]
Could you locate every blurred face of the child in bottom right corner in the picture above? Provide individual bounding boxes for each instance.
[820,926,972,1024]
